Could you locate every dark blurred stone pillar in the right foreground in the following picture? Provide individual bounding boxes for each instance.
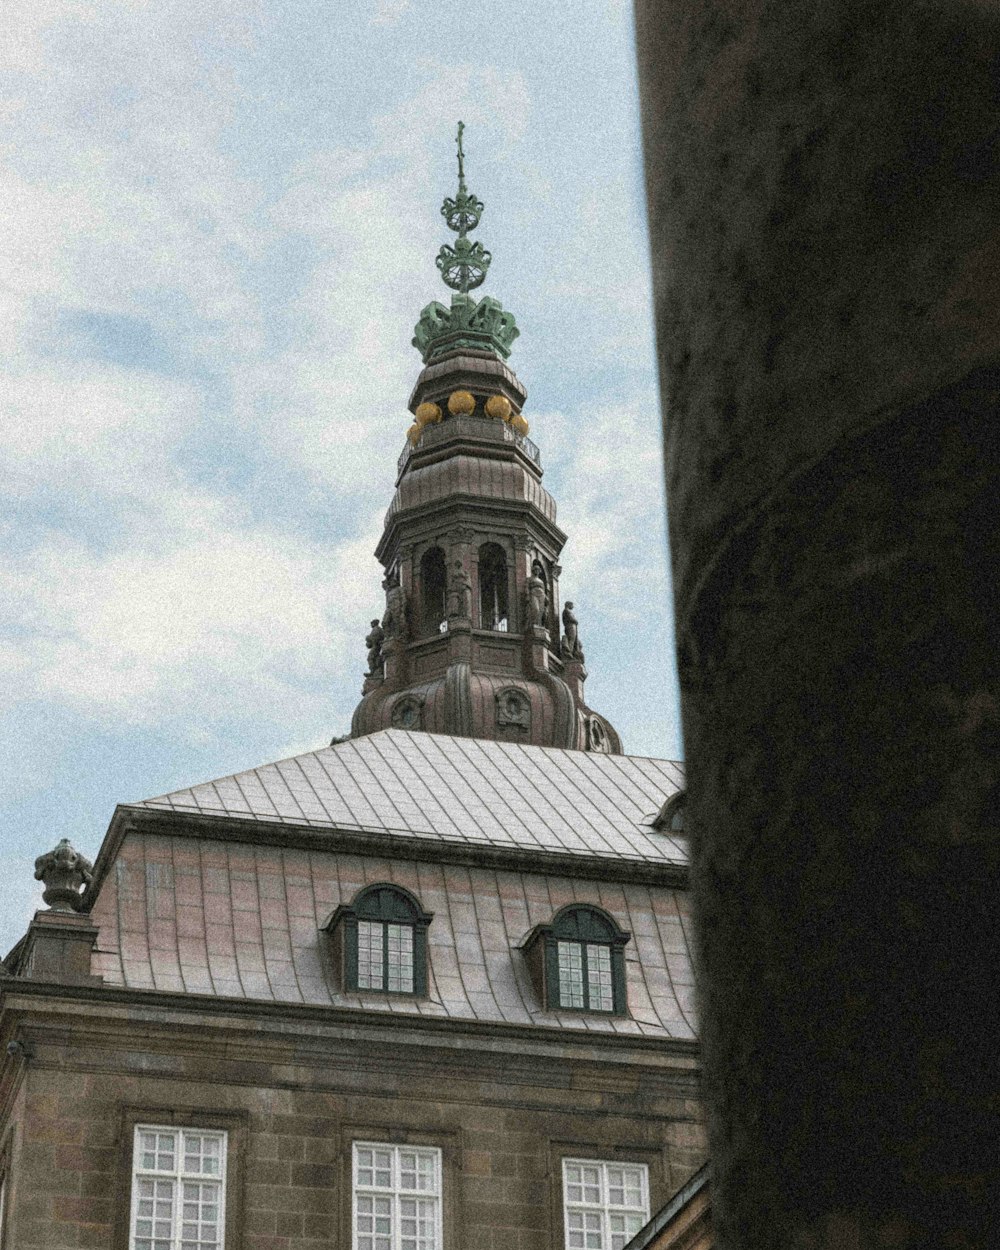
[638,7,1000,1250]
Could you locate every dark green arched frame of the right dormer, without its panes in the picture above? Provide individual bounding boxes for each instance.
[521,903,631,1015]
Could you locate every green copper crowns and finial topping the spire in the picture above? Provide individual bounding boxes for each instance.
[414,121,520,364]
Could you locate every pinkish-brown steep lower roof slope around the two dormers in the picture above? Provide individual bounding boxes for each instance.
[91,833,695,1039]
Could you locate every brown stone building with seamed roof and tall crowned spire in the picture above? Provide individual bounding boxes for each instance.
[0,130,704,1250]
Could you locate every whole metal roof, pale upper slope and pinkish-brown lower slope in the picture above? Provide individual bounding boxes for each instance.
[83,730,695,1039]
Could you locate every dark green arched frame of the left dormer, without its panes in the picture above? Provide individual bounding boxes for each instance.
[323,883,434,998]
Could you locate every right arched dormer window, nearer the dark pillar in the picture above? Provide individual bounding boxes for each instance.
[521,904,631,1015]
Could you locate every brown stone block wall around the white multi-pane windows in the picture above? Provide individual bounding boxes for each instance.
[0,993,704,1250]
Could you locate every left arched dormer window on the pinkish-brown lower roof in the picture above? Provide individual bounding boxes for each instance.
[324,885,434,996]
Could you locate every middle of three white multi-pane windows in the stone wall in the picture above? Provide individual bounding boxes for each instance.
[353,1141,441,1250]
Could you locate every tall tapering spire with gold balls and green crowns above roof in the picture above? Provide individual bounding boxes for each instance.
[351,121,621,754]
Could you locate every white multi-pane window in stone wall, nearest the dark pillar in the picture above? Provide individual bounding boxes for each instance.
[563,1159,649,1250]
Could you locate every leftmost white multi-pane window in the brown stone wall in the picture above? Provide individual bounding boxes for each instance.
[129,1125,226,1250]
